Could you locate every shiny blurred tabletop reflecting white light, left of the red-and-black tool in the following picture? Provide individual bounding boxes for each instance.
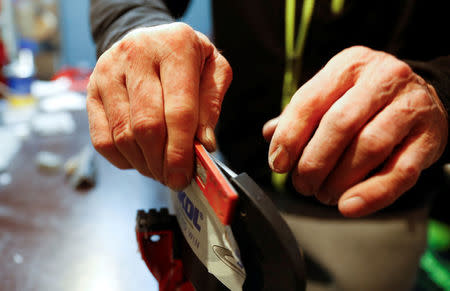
[0,112,167,291]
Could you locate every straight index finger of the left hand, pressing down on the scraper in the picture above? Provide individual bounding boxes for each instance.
[160,28,202,189]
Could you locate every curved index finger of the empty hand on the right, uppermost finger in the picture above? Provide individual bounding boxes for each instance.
[269,47,373,173]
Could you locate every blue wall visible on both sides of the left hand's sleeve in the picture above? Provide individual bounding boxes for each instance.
[60,0,212,67]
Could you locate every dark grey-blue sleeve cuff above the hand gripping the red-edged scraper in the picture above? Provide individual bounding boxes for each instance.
[90,0,189,57]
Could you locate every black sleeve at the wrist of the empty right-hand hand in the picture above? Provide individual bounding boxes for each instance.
[406,56,450,164]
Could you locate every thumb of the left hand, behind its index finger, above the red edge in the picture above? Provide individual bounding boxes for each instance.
[196,44,233,151]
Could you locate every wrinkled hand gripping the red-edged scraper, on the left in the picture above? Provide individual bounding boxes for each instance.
[87,23,232,189]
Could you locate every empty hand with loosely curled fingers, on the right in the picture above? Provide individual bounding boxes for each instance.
[263,47,448,217]
